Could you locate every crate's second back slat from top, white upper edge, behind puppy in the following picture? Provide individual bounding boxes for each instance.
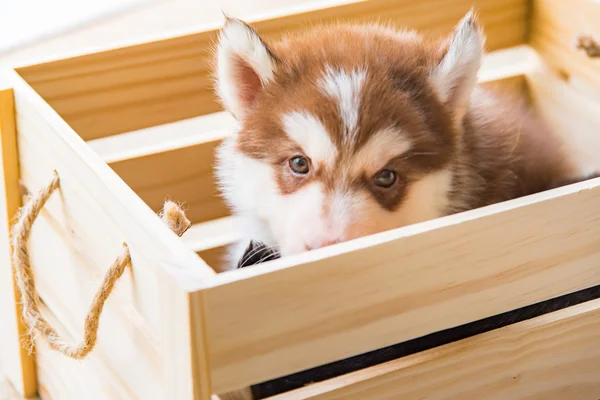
[95,46,531,227]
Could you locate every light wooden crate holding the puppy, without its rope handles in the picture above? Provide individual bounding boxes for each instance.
[0,0,600,400]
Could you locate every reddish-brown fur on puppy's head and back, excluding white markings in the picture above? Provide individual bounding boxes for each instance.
[231,21,574,213]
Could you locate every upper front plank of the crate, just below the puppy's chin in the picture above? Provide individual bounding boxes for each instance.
[200,174,600,393]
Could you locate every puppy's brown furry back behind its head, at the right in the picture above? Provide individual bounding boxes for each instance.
[449,88,583,212]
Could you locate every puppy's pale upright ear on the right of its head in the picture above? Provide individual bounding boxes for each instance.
[430,10,485,123]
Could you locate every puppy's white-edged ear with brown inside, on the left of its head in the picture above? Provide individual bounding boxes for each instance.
[216,15,277,120]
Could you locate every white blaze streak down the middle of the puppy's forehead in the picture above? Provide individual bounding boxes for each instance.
[319,66,367,145]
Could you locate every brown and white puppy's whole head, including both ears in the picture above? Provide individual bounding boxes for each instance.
[216,13,484,255]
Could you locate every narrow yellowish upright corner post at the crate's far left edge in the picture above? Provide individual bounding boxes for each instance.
[0,90,37,396]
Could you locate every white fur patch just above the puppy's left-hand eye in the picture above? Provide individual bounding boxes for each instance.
[283,111,337,164]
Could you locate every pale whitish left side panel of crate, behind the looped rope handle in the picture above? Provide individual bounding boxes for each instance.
[0,74,214,398]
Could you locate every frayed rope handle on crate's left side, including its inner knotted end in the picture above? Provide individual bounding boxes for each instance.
[11,171,191,359]
